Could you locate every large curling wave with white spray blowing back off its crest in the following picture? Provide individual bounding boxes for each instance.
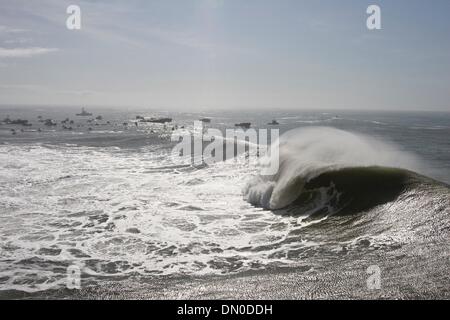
[244,127,421,214]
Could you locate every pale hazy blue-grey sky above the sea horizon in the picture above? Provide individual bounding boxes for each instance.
[0,0,450,111]
